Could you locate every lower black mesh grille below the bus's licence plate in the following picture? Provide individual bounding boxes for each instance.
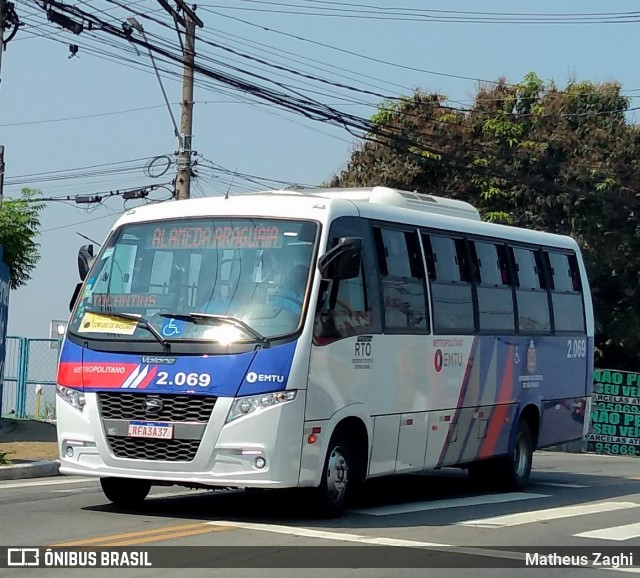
[107,436,200,462]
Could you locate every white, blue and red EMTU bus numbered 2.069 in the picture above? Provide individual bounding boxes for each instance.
[57,187,594,514]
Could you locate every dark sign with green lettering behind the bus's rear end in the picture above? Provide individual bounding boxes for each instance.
[587,369,640,456]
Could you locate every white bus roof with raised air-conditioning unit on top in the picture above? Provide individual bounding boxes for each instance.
[114,187,577,249]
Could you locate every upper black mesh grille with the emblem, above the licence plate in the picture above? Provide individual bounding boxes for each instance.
[98,391,217,423]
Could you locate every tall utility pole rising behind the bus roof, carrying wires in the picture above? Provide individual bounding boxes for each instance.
[174,11,196,200]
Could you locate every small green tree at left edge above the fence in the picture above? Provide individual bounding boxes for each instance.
[0,188,44,289]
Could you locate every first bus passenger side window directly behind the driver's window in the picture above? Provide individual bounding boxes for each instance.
[373,227,428,333]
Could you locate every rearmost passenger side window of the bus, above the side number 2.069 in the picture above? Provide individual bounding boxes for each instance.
[547,252,585,334]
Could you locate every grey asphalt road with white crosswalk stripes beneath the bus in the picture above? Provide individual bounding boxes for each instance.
[0,452,640,578]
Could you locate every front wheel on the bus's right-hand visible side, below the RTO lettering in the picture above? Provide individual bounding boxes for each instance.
[316,435,355,517]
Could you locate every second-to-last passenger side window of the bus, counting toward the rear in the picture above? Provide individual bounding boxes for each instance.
[512,247,551,334]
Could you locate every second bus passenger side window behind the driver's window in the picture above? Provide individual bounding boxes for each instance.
[422,233,475,335]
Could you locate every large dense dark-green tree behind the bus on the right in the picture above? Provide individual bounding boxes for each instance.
[328,73,640,370]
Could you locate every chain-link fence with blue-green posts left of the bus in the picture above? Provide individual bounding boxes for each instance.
[0,337,59,420]
